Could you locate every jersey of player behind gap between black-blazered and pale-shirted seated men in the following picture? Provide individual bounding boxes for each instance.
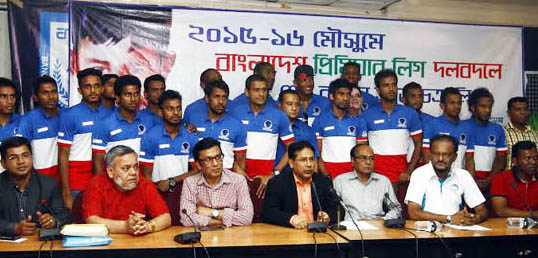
[312,111,367,178]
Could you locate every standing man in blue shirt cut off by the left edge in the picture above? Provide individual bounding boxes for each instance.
[0,78,21,146]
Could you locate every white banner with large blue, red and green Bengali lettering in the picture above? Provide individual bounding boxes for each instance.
[166,9,523,123]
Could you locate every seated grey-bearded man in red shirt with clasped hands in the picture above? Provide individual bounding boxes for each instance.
[82,145,172,235]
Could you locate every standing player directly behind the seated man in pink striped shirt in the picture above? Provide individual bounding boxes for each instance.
[187,81,248,178]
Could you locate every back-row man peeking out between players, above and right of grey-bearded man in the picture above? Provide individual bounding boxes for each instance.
[139,74,166,125]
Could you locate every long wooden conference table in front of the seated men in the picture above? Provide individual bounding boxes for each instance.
[0,218,538,258]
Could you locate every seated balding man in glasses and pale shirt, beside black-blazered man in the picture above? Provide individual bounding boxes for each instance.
[333,144,401,221]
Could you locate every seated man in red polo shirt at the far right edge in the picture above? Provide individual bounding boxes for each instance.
[490,141,538,218]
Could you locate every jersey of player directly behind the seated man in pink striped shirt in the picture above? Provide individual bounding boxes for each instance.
[188,112,247,169]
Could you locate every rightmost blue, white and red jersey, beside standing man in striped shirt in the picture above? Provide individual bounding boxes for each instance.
[462,117,507,179]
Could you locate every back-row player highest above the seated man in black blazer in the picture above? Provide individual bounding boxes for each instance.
[293,65,331,126]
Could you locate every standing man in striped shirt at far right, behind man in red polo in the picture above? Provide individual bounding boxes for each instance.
[503,97,538,170]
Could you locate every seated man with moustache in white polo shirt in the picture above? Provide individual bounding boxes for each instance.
[405,135,488,225]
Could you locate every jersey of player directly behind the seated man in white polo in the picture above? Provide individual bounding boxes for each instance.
[422,115,474,169]
